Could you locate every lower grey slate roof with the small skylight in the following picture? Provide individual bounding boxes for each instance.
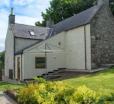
[12,23,50,40]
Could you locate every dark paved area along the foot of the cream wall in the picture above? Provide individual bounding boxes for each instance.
[44,68,108,80]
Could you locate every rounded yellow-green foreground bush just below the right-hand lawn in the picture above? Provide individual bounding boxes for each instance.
[56,86,100,104]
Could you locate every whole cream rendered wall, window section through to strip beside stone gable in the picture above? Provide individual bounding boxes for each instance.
[23,25,91,79]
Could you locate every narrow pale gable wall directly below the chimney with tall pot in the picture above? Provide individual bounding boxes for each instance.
[5,27,14,78]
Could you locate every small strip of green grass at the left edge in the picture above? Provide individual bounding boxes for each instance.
[0,82,24,91]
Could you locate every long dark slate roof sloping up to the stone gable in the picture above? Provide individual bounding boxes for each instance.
[48,5,101,38]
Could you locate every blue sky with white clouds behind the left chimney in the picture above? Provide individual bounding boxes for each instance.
[0,0,50,51]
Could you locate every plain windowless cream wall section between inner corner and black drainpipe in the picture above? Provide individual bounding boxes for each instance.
[66,27,85,69]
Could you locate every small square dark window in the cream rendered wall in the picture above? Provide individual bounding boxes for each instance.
[35,57,46,69]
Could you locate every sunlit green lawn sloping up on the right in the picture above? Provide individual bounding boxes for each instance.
[64,68,114,95]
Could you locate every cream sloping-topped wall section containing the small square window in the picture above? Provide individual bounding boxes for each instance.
[23,32,65,79]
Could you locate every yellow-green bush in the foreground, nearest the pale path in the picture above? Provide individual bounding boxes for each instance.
[17,82,64,104]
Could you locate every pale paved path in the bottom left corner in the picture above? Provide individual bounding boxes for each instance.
[0,92,16,104]
